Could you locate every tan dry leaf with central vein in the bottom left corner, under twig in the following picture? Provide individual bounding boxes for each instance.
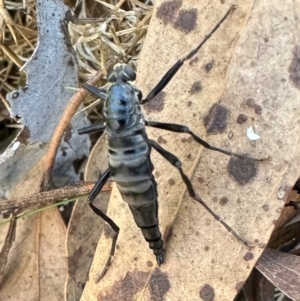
[0,163,67,301]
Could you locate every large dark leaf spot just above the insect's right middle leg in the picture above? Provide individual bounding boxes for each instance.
[204,104,228,134]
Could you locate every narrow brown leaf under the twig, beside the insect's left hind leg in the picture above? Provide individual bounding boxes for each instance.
[66,136,110,301]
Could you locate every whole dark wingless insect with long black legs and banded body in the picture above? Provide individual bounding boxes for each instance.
[78,6,256,279]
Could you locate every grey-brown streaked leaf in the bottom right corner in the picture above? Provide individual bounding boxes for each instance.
[256,248,300,300]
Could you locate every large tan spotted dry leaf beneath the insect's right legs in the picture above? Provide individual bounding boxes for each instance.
[81,0,300,301]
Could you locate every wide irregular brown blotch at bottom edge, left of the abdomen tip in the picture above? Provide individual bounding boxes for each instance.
[97,268,149,301]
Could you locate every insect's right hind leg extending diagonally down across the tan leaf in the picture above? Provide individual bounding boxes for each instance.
[149,140,249,247]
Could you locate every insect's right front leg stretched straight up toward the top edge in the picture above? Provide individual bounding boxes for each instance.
[141,5,236,104]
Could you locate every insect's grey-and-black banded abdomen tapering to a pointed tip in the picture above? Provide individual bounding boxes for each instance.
[107,129,164,260]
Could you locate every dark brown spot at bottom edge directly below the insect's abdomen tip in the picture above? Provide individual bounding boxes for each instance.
[149,268,171,301]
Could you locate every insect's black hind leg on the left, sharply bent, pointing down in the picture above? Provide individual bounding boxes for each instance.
[87,168,120,282]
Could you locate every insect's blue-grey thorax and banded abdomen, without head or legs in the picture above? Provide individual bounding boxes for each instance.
[103,72,164,261]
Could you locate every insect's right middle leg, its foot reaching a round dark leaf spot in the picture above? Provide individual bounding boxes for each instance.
[145,120,265,161]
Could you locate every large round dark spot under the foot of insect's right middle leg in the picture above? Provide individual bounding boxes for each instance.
[227,157,256,185]
